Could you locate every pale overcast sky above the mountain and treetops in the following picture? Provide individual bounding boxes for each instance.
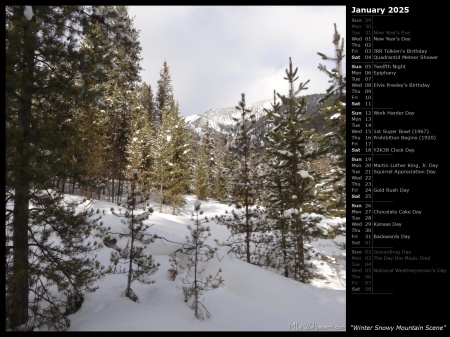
[129,6,346,116]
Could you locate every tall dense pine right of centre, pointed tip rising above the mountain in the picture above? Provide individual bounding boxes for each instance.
[265,58,326,283]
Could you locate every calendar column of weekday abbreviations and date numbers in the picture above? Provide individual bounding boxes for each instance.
[349,16,373,293]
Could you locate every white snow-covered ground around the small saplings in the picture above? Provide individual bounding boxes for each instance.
[67,196,346,331]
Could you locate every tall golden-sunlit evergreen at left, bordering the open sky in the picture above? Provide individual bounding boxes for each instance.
[88,6,141,203]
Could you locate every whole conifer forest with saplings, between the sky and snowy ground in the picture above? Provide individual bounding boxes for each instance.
[5,5,346,331]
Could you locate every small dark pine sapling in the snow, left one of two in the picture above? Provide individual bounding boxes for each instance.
[106,170,159,302]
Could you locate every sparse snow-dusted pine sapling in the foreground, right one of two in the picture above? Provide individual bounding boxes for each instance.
[170,200,224,319]
